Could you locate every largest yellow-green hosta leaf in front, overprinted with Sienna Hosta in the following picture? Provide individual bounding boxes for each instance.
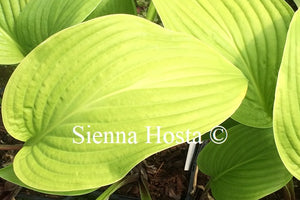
[2,15,247,191]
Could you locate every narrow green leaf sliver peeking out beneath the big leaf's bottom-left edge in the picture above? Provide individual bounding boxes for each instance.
[0,165,95,195]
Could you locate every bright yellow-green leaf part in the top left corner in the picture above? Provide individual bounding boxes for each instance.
[0,0,29,64]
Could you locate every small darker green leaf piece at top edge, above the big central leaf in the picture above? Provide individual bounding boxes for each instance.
[87,0,136,20]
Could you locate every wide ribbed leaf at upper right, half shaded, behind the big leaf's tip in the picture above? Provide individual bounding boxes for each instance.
[153,0,293,127]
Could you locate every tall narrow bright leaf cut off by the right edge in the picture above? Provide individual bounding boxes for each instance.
[274,11,300,179]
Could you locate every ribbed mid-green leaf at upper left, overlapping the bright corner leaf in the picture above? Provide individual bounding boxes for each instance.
[16,0,101,53]
